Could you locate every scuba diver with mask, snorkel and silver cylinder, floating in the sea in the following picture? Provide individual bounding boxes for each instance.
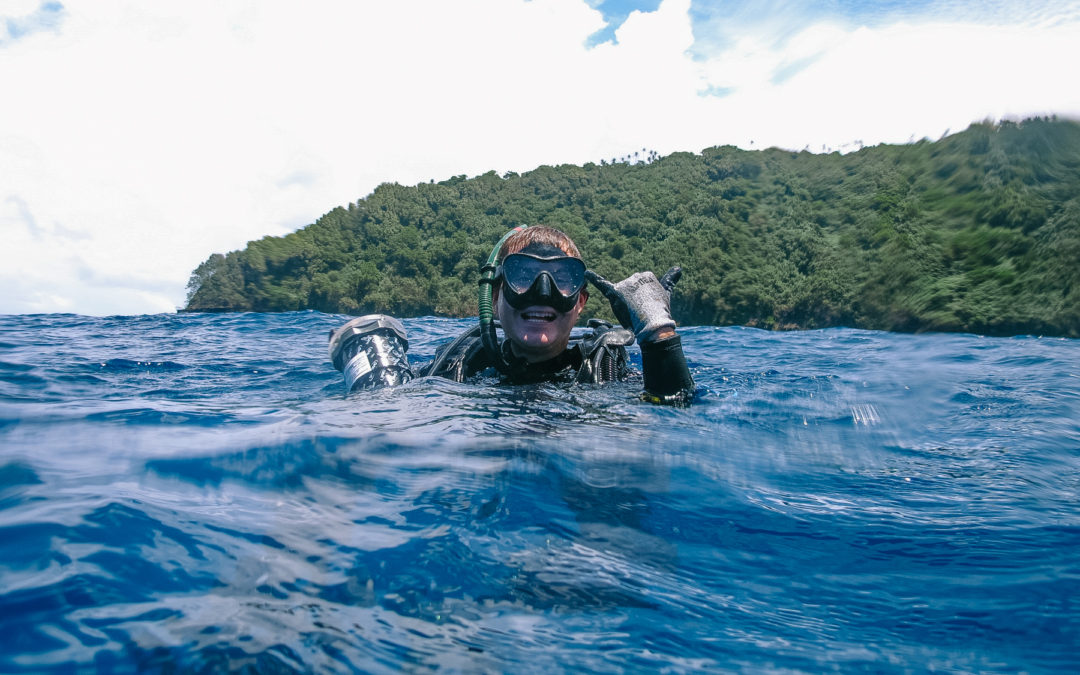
[329,226,693,404]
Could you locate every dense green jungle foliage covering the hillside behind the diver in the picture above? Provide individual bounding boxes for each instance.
[187,119,1080,337]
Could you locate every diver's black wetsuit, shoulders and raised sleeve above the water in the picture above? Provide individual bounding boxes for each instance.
[417,319,693,403]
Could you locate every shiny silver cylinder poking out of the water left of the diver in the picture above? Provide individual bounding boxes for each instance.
[329,314,413,392]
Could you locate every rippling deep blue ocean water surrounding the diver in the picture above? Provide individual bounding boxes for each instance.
[0,312,1080,673]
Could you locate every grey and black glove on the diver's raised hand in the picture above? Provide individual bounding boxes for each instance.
[585,267,683,343]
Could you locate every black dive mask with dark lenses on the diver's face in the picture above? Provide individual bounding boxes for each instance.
[497,253,585,312]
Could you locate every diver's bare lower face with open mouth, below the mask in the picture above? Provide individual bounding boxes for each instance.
[495,288,589,363]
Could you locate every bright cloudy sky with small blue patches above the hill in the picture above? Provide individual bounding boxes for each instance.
[0,0,1080,315]
